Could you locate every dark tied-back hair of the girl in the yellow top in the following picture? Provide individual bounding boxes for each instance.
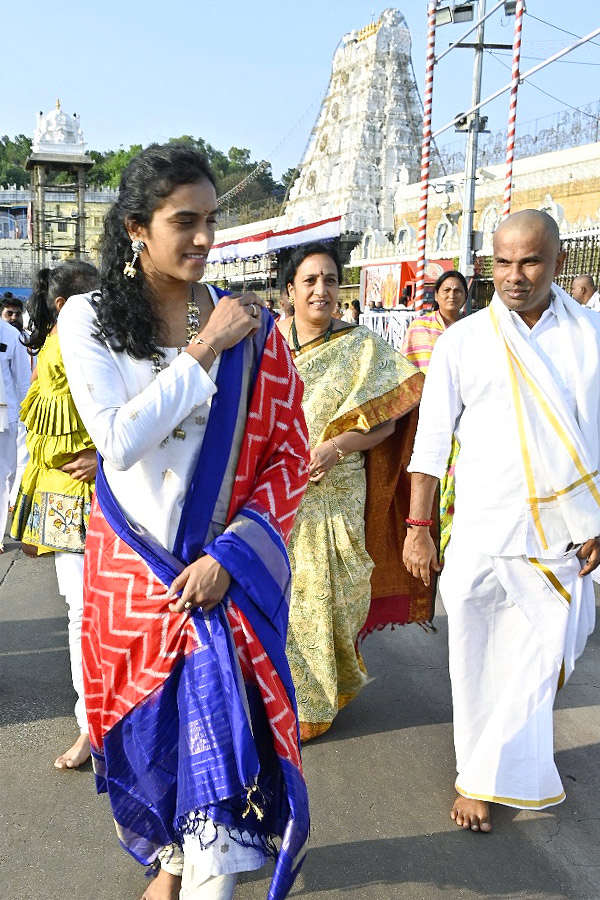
[26,259,100,355]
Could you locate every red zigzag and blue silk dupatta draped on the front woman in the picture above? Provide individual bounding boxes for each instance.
[82,313,309,900]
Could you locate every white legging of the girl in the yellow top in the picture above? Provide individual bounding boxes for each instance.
[54,552,88,734]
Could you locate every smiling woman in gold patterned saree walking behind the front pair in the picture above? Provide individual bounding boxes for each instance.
[278,244,431,741]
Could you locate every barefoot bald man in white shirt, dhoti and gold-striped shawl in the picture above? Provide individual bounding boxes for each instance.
[404,210,600,831]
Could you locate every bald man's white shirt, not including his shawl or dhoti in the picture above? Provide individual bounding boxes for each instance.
[408,298,600,556]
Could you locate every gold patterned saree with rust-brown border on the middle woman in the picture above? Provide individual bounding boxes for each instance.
[287,326,431,740]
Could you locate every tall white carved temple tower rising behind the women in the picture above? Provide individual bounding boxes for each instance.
[282,9,423,234]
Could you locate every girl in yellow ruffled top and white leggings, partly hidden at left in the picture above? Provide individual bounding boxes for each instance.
[11,260,98,769]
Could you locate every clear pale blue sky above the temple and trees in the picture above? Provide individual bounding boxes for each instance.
[0,0,600,177]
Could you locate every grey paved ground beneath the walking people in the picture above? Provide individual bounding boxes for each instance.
[0,540,600,900]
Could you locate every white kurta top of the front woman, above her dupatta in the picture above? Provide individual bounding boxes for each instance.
[58,296,219,550]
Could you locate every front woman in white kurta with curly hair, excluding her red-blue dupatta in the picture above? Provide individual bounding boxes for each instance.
[59,146,264,900]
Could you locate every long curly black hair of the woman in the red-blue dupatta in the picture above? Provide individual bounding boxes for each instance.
[94,143,216,359]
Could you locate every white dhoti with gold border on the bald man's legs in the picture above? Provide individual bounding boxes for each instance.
[440,532,595,809]
